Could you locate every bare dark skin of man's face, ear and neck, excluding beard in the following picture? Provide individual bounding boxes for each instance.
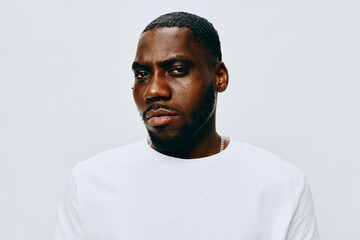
[133,27,229,159]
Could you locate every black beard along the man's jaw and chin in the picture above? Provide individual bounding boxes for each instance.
[148,83,215,152]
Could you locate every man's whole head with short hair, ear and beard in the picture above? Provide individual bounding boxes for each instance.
[132,13,228,152]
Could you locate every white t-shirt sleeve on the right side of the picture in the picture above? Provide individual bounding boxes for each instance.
[286,178,320,240]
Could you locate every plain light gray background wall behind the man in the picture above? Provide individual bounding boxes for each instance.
[0,0,360,240]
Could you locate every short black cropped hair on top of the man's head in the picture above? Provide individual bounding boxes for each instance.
[142,12,222,63]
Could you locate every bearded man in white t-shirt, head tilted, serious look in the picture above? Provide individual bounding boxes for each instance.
[53,12,318,240]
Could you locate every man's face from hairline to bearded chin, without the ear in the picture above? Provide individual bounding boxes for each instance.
[133,27,216,151]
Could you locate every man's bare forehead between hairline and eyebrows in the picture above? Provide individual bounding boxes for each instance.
[135,27,208,61]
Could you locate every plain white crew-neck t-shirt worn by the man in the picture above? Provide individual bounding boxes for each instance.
[52,140,319,240]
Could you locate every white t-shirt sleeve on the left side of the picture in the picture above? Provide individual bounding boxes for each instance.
[51,170,83,240]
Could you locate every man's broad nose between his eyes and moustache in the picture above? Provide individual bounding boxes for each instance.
[143,72,171,102]
